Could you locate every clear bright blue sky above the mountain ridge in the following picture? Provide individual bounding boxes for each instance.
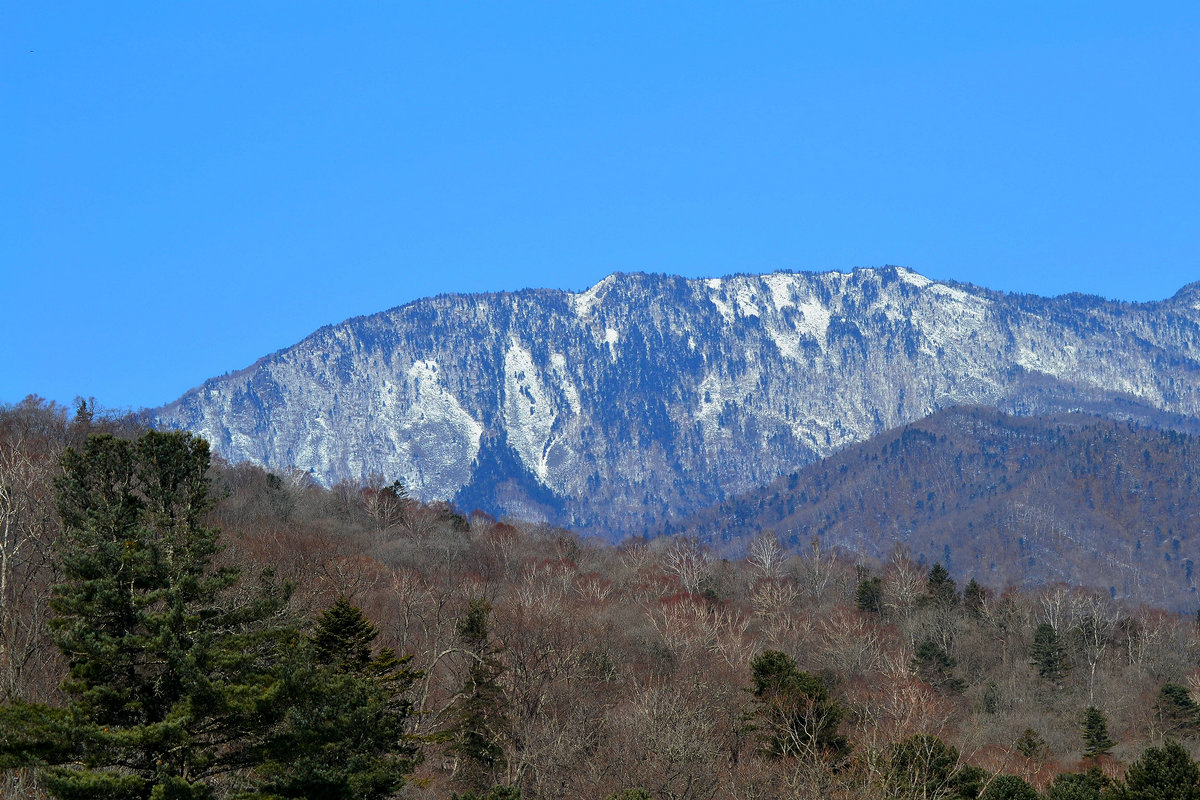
[0,0,1200,408]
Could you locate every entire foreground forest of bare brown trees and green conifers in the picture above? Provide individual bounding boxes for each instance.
[0,398,1200,800]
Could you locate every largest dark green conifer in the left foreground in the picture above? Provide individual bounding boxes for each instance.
[0,432,422,800]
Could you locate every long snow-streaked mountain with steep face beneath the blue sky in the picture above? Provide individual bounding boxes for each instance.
[155,267,1200,536]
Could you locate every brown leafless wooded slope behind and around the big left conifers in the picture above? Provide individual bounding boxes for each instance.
[0,401,1200,800]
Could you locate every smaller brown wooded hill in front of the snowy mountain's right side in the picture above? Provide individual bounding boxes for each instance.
[670,408,1200,610]
